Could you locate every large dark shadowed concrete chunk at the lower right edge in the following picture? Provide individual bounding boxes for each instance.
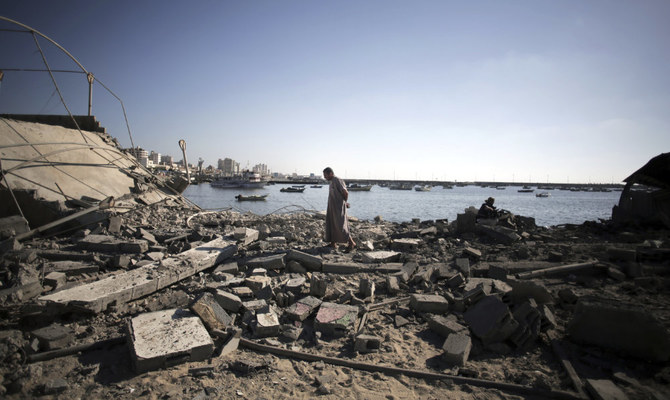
[568,298,670,362]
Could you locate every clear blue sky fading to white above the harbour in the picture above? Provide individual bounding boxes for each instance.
[0,0,670,183]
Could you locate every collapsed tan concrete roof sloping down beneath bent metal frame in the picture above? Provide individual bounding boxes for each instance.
[0,116,185,227]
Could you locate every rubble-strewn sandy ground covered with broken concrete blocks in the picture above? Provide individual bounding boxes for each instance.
[0,200,670,399]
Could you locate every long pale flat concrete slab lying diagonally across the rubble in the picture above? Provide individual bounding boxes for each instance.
[39,239,237,313]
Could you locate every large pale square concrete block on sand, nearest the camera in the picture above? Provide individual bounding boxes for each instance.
[128,309,214,373]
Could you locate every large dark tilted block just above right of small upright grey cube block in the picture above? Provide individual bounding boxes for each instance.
[463,295,519,344]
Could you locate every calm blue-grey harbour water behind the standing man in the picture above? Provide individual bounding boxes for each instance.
[184,183,621,226]
